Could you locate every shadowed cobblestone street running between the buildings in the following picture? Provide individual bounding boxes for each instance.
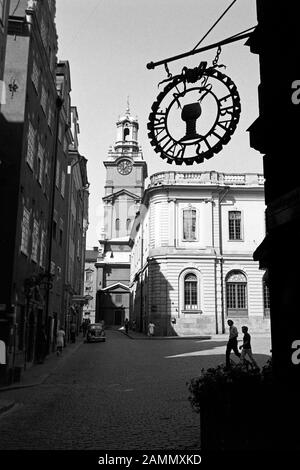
[0,330,270,451]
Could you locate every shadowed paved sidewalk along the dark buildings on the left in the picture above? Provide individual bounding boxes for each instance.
[0,335,84,415]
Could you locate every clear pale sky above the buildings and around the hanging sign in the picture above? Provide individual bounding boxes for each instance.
[56,0,263,248]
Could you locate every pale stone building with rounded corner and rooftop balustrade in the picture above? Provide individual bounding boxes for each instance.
[130,171,269,336]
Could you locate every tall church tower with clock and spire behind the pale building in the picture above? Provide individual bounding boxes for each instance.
[95,103,147,326]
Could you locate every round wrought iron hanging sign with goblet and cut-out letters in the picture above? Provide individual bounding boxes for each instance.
[147,60,241,165]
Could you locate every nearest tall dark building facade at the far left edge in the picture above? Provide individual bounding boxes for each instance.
[0,1,58,378]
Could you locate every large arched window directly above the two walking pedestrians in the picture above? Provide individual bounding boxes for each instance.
[226,271,248,317]
